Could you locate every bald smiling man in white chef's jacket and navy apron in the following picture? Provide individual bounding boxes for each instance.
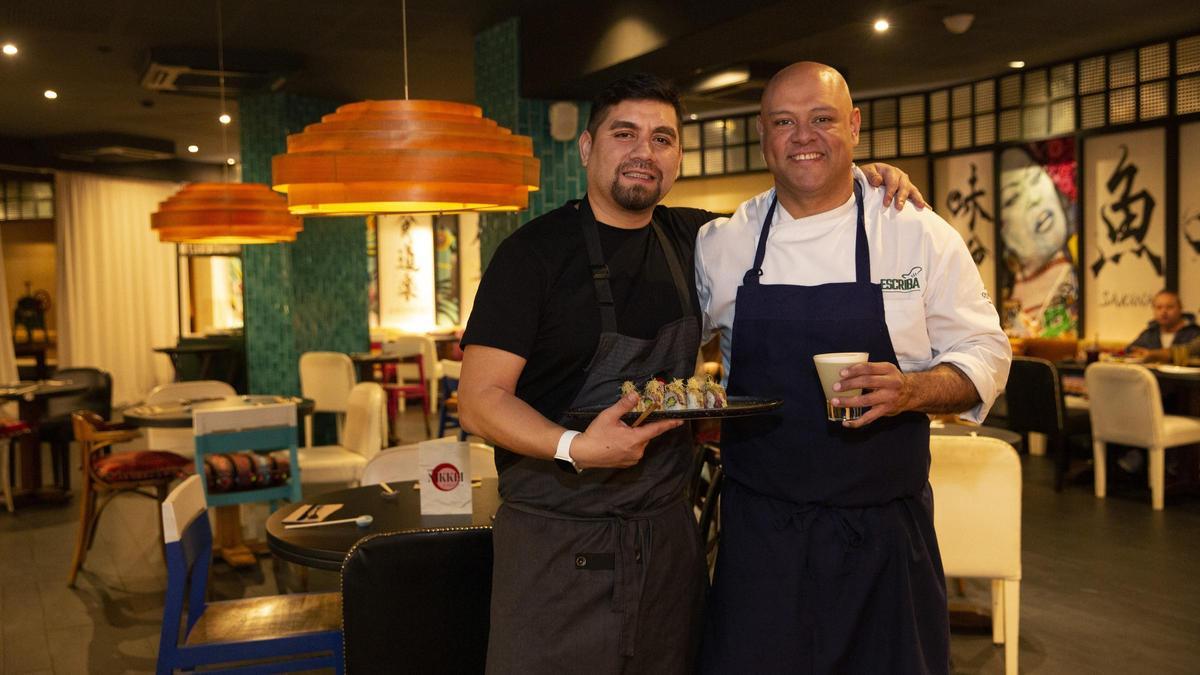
[696,62,1012,673]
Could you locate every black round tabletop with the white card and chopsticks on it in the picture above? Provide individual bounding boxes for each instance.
[266,478,500,571]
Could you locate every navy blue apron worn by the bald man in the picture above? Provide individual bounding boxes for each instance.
[701,181,949,674]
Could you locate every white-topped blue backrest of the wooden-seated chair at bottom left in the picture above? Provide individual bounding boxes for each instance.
[160,476,212,649]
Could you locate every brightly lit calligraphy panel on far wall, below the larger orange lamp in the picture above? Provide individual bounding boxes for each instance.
[377,215,437,331]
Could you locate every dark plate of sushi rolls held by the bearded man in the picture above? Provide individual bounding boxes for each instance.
[566,377,784,422]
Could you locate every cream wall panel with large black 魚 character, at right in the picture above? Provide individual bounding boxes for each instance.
[1082,129,1166,340]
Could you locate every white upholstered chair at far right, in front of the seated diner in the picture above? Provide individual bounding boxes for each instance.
[1084,363,1200,510]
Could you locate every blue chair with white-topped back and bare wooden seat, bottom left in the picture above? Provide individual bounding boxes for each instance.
[156,476,344,674]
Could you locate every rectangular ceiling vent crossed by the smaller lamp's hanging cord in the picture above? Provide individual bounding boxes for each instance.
[142,47,304,97]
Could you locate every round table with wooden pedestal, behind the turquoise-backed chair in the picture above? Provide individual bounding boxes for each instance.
[122,394,316,567]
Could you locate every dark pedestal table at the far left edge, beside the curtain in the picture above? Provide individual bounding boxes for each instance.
[0,380,88,506]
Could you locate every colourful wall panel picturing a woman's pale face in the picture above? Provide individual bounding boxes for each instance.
[1000,138,1079,338]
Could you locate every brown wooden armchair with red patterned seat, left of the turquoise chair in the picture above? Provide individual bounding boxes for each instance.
[67,411,191,586]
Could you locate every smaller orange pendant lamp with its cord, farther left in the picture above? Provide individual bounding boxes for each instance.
[150,0,304,244]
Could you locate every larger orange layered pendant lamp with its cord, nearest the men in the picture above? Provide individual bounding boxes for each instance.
[271,2,539,215]
